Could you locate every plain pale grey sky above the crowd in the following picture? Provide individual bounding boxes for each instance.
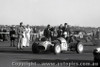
[0,0,100,27]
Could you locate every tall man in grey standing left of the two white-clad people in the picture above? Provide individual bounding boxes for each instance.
[17,22,24,49]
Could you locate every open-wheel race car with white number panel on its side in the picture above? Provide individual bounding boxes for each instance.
[32,37,84,54]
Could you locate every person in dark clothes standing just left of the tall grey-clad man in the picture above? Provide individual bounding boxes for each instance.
[10,26,16,47]
